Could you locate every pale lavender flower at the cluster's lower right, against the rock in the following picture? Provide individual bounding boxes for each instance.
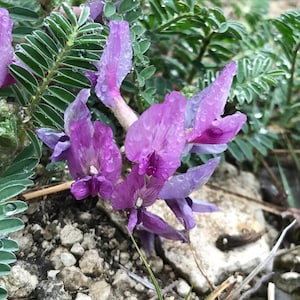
[159,158,220,230]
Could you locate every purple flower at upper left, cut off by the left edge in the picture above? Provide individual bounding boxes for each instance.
[0,8,15,88]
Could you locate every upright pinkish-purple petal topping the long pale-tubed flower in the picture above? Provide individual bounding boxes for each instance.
[95,21,132,107]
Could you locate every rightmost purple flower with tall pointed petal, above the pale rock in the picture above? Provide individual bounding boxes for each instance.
[185,62,246,153]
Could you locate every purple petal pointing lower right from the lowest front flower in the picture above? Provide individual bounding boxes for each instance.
[138,211,187,242]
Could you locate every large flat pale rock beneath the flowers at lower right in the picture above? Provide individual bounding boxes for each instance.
[151,164,270,292]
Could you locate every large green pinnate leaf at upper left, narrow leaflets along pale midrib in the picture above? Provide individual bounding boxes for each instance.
[10,6,104,128]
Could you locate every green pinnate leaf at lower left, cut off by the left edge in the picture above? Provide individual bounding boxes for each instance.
[0,131,41,299]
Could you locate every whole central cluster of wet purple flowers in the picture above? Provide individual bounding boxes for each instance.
[33,17,246,242]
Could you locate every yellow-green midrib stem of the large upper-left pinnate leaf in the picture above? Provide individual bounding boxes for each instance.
[28,26,78,119]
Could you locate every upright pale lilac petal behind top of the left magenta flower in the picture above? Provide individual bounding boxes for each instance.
[64,89,91,135]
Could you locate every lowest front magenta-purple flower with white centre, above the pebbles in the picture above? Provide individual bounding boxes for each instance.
[111,166,186,241]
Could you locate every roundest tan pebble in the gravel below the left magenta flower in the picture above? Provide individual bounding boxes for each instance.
[79,250,104,277]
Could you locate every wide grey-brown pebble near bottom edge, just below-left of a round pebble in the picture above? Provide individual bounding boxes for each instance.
[57,266,90,291]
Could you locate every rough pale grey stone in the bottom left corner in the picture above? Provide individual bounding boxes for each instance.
[0,265,38,298]
